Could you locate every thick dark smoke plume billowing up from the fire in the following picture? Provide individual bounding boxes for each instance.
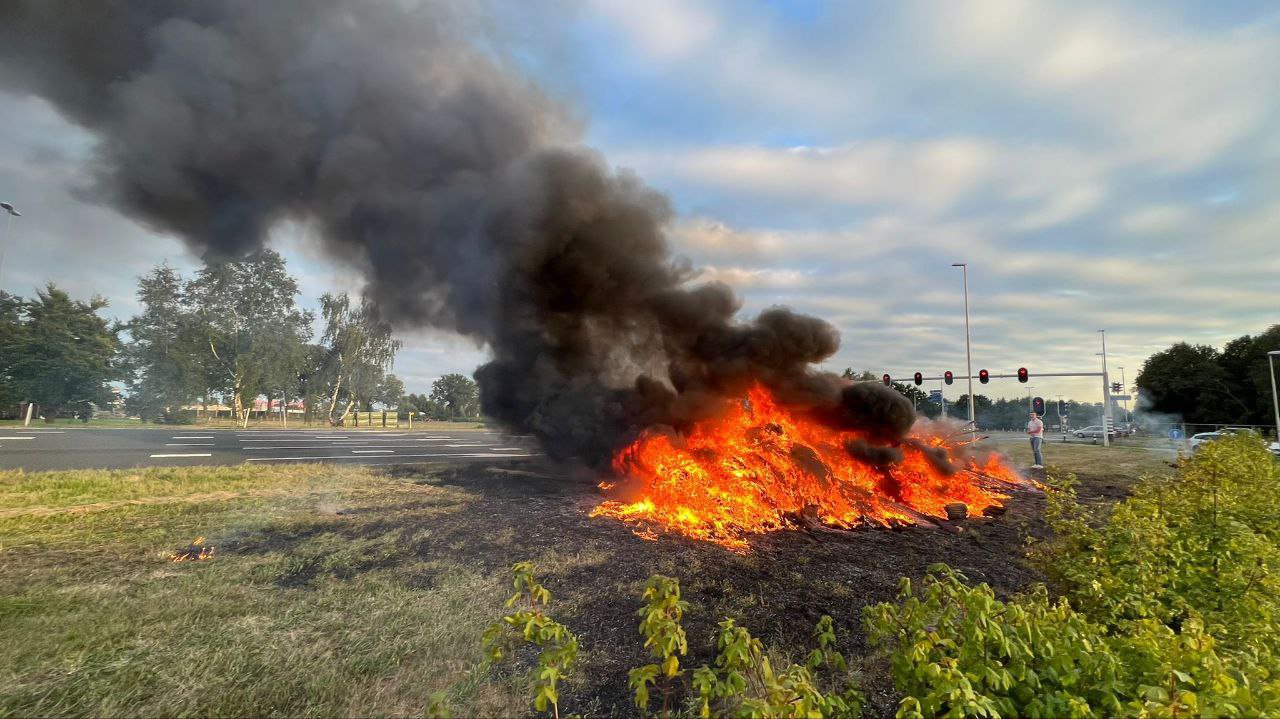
[0,0,913,463]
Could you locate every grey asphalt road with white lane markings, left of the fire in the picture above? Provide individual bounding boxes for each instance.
[0,426,540,471]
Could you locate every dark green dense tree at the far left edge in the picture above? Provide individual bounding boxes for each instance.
[0,284,123,421]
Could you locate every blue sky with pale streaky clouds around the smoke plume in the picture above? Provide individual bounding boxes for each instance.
[0,0,1280,399]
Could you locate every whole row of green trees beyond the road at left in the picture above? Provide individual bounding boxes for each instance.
[0,249,479,425]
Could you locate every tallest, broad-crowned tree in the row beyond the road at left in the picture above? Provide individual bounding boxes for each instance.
[187,249,312,416]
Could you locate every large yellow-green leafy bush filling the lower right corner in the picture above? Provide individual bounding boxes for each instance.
[865,436,1280,716]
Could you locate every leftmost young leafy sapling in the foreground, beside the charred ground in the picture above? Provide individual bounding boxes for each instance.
[481,562,577,719]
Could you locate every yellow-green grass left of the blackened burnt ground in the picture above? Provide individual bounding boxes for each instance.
[0,466,525,716]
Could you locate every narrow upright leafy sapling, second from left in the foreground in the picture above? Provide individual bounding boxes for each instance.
[627,574,689,718]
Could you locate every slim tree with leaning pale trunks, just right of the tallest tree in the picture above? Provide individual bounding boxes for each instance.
[320,293,401,423]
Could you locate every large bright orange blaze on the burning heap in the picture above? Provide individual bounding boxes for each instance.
[593,386,1024,550]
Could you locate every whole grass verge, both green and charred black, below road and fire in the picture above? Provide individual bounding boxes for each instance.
[0,446,1164,715]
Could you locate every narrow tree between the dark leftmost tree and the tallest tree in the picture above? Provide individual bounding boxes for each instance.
[124,265,207,420]
